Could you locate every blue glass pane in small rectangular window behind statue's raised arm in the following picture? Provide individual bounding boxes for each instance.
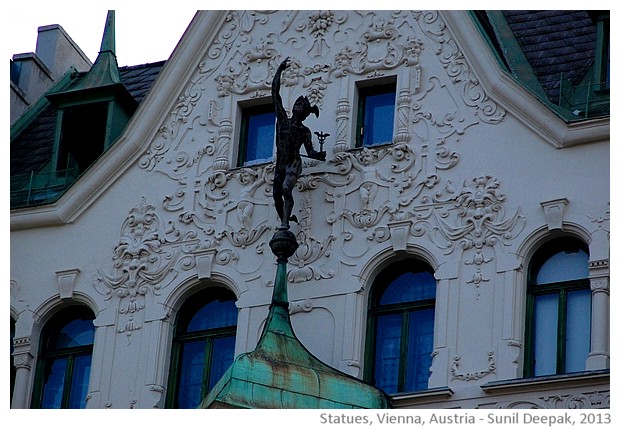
[244,112,276,164]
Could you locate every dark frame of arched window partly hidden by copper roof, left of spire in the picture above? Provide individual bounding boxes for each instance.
[166,286,238,409]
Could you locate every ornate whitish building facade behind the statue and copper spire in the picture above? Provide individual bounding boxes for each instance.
[11,11,610,408]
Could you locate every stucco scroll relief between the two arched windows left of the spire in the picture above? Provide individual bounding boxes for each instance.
[94,197,198,338]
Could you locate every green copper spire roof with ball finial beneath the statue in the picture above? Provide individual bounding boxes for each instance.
[200,229,390,409]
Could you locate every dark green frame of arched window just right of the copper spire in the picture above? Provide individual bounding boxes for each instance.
[364,259,437,394]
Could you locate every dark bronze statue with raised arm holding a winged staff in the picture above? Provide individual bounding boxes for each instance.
[271,58,326,229]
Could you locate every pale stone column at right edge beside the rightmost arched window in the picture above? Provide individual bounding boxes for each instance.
[586,260,610,370]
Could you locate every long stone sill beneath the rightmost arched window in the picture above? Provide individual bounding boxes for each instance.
[480,369,609,394]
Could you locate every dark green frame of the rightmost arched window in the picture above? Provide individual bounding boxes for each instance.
[523,237,592,378]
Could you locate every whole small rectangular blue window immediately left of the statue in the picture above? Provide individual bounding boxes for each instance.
[239,105,276,166]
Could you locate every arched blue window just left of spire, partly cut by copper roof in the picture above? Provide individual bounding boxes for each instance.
[167,288,238,408]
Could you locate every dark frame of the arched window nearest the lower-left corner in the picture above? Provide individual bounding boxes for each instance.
[32,305,95,409]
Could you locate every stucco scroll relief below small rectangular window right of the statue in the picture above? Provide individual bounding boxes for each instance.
[326,139,459,257]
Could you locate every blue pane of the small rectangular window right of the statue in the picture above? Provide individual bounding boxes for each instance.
[363,92,396,146]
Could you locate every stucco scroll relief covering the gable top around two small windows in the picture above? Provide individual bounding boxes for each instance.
[140,11,505,178]
